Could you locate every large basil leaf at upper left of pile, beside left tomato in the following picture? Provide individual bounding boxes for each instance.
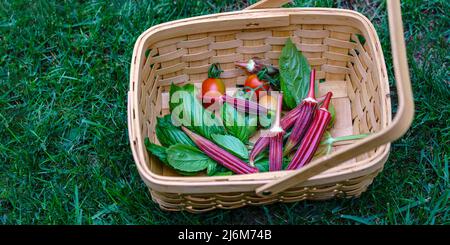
[169,84,225,139]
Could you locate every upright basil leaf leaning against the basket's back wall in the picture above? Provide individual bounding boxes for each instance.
[279,38,311,109]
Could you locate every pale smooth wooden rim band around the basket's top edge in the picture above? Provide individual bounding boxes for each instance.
[128,8,392,193]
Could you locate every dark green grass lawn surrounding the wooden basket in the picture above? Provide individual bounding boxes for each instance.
[0,0,450,224]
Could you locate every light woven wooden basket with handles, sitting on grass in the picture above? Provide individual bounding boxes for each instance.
[128,0,414,213]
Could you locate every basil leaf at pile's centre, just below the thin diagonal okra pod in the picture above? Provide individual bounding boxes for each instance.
[220,93,258,144]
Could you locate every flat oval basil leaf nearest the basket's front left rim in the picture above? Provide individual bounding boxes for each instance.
[166,144,217,172]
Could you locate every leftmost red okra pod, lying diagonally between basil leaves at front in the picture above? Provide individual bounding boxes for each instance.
[181,127,259,174]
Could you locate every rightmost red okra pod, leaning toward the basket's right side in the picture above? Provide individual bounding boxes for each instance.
[287,92,333,170]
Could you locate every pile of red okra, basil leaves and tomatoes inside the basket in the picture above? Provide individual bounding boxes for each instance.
[145,39,366,176]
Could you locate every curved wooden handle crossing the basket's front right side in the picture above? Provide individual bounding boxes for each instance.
[256,0,414,196]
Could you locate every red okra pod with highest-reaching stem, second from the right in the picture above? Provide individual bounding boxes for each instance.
[284,70,318,154]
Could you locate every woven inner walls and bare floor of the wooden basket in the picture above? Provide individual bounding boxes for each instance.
[132,10,388,176]
